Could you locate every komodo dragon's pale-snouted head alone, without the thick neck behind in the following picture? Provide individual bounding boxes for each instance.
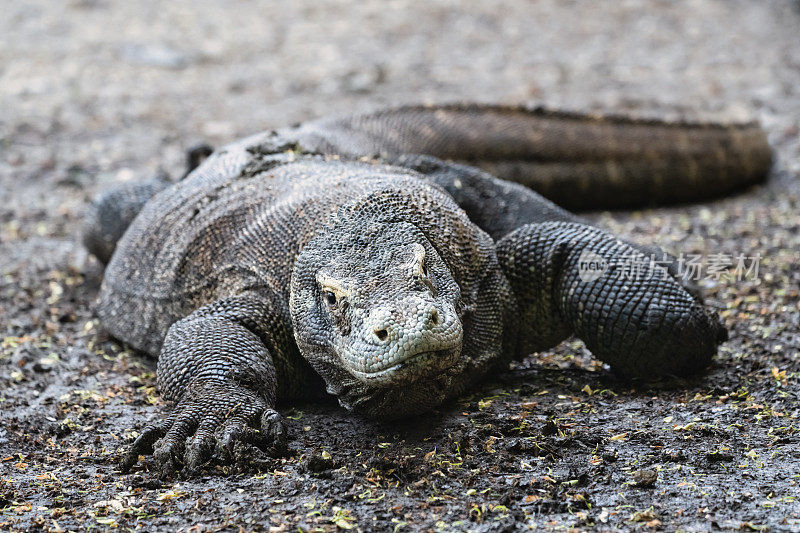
[291,216,463,390]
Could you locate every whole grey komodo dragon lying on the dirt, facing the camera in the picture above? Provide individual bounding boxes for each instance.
[85,105,771,474]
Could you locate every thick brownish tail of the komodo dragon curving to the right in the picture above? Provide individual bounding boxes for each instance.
[290,104,772,210]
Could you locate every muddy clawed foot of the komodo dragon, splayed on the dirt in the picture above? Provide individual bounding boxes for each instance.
[120,381,286,477]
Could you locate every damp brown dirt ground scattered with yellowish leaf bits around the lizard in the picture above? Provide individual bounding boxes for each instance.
[0,0,800,531]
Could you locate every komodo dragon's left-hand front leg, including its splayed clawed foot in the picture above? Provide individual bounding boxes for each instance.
[121,296,286,475]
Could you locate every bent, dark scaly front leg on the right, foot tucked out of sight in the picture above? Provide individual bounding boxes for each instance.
[497,222,727,377]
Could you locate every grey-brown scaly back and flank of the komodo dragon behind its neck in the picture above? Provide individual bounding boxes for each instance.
[98,143,489,355]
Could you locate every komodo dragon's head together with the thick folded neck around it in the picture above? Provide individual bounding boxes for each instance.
[289,181,513,419]
